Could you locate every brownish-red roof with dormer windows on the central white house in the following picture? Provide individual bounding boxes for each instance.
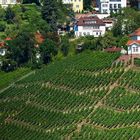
[77,16,105,26]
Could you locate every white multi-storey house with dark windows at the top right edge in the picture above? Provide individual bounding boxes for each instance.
[99,0,127,14]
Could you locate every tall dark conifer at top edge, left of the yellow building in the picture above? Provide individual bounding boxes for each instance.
[42,0,58,32]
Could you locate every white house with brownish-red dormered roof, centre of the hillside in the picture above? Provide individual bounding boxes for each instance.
[74,15,106,37]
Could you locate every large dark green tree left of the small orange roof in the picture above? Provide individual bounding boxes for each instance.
[7,31,35,66]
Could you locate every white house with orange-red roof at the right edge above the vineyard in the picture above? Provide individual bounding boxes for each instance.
[127,28,140,55]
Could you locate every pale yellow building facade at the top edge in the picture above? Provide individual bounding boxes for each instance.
[62,0,83,12]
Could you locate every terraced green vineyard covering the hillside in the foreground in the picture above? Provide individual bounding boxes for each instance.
[0,52,140,140]
